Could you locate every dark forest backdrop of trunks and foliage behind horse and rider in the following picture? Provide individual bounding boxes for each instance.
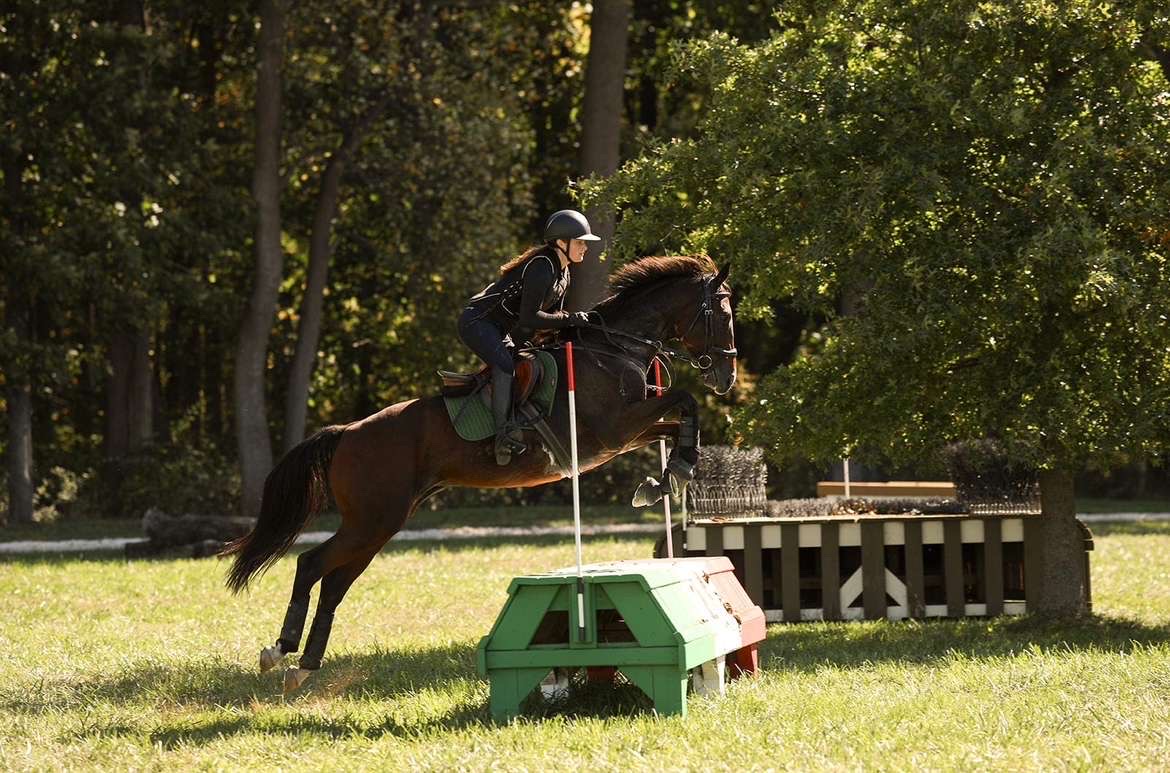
[0,0,1170,523]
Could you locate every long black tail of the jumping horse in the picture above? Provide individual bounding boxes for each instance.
[220,426,345,593]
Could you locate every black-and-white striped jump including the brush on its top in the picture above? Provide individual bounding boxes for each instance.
[682,447,1093,622]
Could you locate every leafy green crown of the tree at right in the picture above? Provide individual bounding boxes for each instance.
[589,0,1170,467]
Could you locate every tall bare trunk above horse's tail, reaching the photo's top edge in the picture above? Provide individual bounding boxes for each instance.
[234,0,284,516]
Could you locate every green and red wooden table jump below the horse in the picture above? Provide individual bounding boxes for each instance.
[476,557,765,720]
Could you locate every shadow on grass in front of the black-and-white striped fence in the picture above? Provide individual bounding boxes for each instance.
[759,615,1170,671]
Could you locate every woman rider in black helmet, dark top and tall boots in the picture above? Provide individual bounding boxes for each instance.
[459,209,599,465]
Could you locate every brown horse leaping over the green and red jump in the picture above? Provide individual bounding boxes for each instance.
[223,256,736,692]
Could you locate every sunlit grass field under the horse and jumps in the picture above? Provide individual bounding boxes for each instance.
[0,523,1170,771]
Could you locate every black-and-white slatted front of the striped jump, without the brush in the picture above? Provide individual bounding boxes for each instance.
[686,515,1092,622]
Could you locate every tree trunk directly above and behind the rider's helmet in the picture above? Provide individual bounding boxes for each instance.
[566,0,629,311]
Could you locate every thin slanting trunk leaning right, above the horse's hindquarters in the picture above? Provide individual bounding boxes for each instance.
[284,101,390,451]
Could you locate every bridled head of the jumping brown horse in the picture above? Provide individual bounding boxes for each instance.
[679,265,737,394]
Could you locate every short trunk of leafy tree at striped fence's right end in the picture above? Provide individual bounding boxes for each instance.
[1027,470,1089,617]
